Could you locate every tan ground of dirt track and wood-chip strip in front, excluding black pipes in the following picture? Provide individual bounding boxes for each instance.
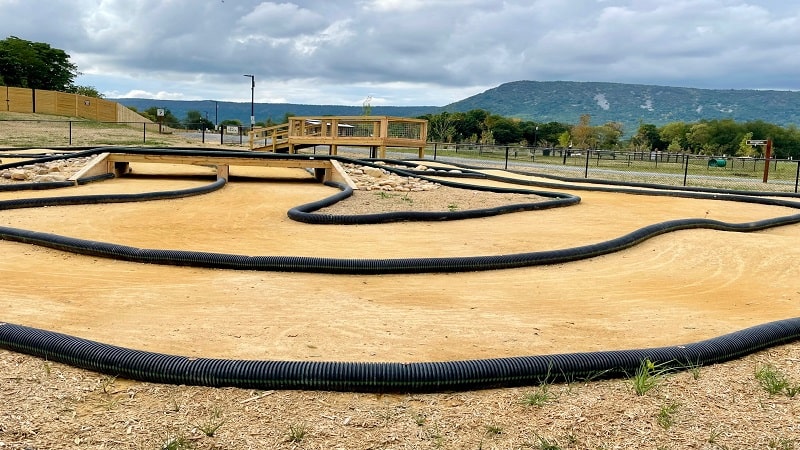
[0,159,800,449]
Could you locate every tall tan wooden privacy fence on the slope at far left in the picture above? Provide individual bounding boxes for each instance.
[0,86,152,123]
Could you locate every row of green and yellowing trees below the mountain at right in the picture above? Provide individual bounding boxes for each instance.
[420,109,800,158]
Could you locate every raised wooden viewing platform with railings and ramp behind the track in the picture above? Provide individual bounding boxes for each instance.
[249,116,428,158]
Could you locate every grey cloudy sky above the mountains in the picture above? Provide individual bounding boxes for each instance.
[0,0,800,106]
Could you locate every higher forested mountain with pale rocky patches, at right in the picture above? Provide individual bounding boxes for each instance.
[444,81,800,134]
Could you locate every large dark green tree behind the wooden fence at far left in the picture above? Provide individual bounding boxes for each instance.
[0,36,79,92]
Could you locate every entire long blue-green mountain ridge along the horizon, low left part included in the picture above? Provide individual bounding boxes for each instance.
[110,80,800,134]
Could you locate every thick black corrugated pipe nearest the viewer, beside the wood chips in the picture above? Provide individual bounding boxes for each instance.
[0,318,800,392]
